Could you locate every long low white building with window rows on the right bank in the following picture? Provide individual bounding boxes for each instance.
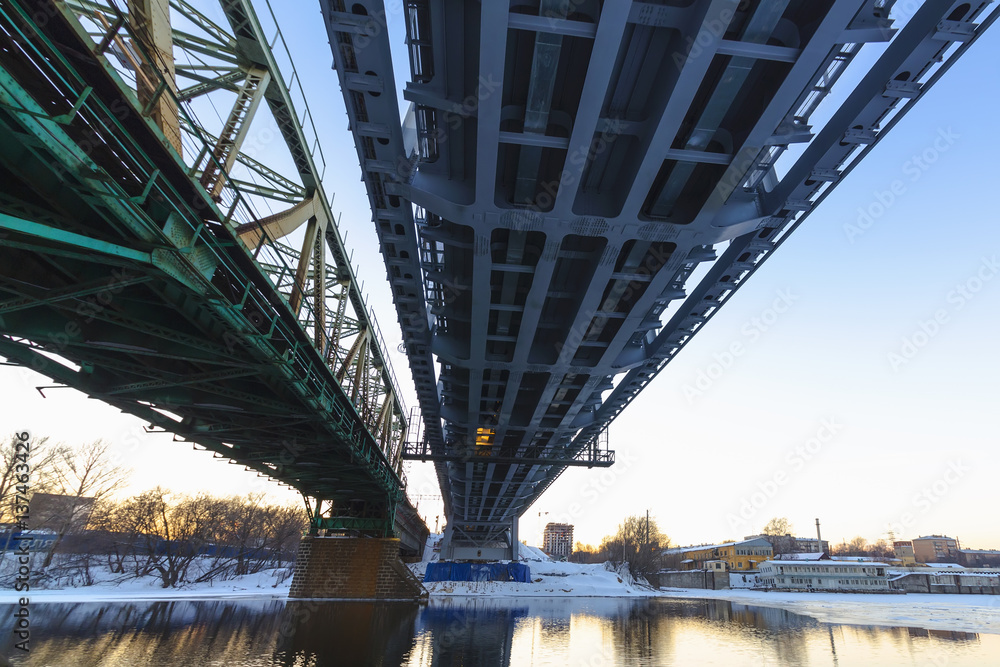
[757,560,890,592]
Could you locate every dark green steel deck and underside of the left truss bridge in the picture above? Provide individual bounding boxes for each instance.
[0,0,416,536]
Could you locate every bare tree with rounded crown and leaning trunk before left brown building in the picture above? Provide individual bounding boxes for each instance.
[42,440,131,570]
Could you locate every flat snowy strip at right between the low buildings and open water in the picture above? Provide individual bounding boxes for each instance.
[660,588,1000,634]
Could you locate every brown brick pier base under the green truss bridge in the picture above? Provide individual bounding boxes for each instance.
[288,535,427,600]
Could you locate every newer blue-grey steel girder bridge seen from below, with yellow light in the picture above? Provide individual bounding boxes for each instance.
[320,0,997,558]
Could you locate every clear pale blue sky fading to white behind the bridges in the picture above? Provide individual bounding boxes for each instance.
[0,0,1000,548]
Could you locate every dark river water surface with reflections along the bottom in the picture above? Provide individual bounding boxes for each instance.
[0,598,1000,667]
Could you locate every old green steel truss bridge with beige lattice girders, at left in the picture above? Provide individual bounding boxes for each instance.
[0,0,427,588]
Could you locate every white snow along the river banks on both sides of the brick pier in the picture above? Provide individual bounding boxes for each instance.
[7,543,1000,634]
